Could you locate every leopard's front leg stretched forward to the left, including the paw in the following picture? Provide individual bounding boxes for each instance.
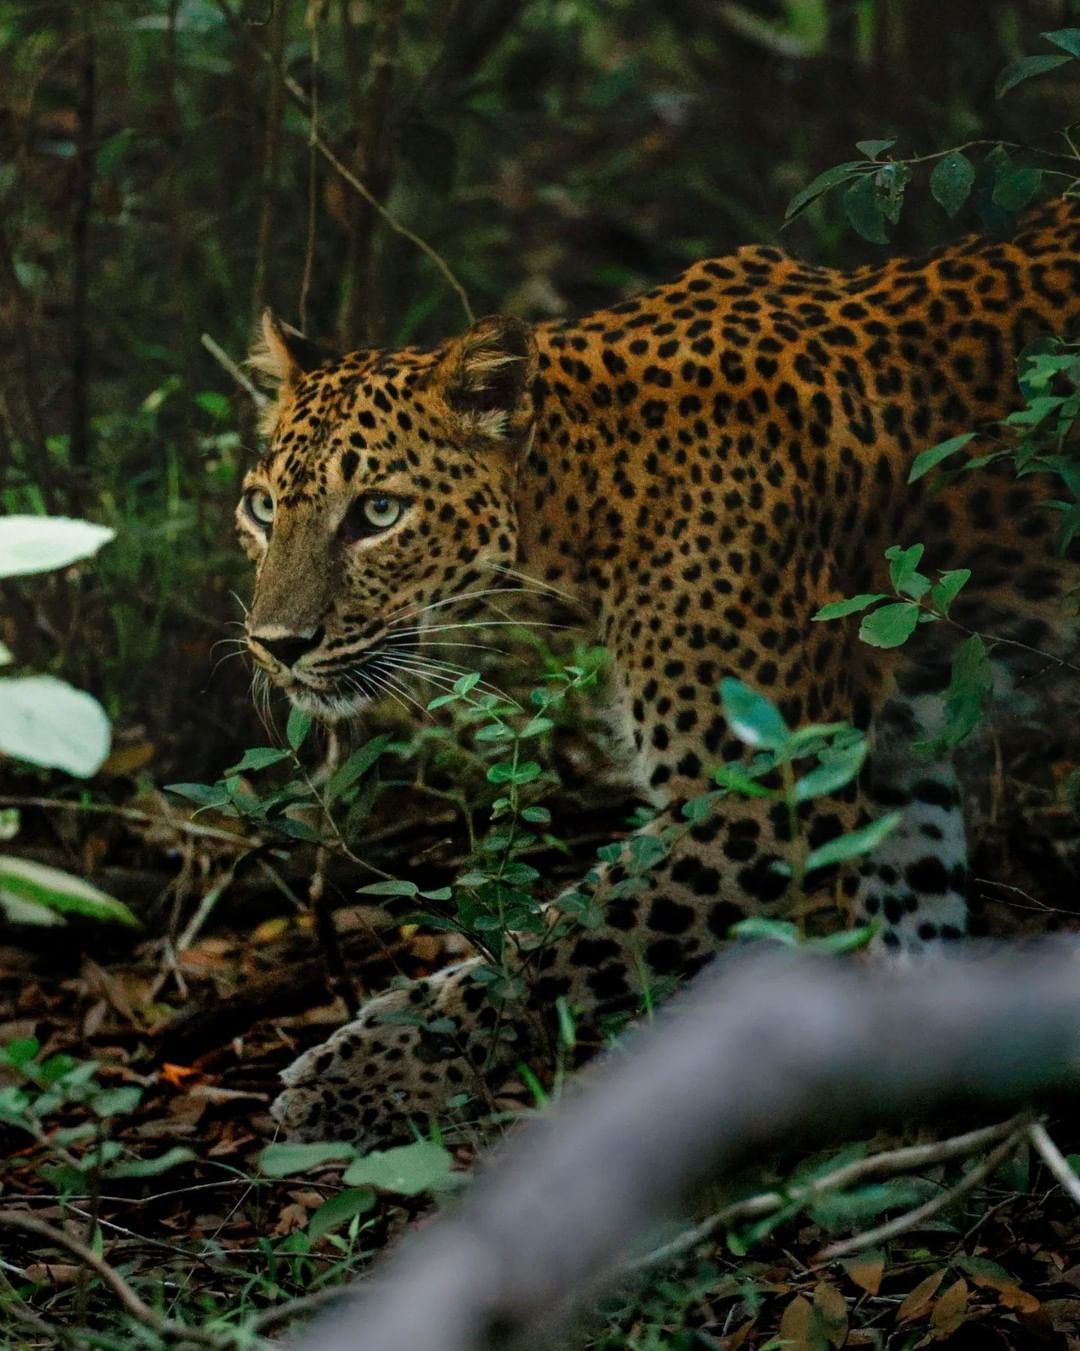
[273,798,850,1147]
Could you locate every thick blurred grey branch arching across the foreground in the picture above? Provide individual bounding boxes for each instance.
[301,942,1080,1351]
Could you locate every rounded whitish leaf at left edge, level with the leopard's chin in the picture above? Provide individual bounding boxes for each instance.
[0,676,111,778]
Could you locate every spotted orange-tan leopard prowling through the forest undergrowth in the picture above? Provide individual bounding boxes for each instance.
[237,199,1080,1148]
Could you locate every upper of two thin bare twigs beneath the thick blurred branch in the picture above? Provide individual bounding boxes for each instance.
[619,1115,1029,1271]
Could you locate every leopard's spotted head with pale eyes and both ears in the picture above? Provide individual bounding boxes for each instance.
[237,312,537,719]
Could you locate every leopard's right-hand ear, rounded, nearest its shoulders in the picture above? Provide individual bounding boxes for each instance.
[439,315,537,442]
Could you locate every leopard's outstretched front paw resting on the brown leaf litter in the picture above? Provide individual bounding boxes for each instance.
[270,966,489,1148]
